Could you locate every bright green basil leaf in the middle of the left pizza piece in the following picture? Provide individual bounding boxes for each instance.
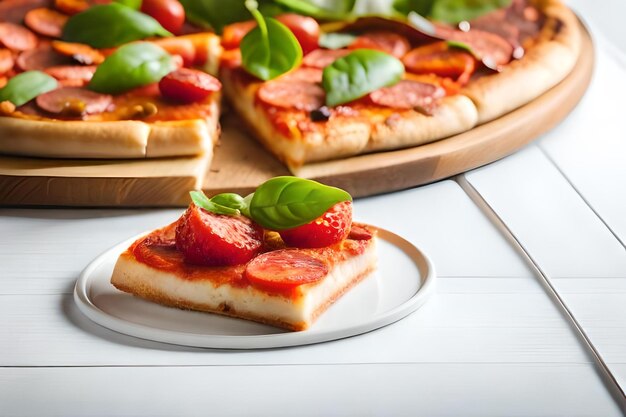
[88,42,176,94]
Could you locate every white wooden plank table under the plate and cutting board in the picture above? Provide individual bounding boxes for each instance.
[0,0,626,417]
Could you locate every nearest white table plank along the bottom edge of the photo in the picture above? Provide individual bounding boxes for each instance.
[0,364,621,417]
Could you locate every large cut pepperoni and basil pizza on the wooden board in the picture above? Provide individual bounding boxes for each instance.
[0,0,580,172]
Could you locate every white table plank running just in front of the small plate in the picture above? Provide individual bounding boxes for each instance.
[0,293,590,366]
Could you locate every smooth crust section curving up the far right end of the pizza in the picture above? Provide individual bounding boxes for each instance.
[461,1,581,124]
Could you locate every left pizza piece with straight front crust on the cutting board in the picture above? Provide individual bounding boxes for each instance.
[0,0,221,158]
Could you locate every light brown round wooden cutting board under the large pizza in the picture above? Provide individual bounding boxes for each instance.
[0,24,594,207]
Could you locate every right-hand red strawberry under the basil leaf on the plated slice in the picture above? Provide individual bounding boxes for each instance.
[279,201,352,248]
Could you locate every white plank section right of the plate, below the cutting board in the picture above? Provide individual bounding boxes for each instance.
[355,181,532,277]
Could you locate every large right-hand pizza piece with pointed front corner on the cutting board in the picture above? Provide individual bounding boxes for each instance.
[220,0,579,173]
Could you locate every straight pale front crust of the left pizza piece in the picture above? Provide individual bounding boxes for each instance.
[0,95,220,159]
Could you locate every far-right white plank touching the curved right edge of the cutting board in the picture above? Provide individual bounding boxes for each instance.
[539,41,626,244]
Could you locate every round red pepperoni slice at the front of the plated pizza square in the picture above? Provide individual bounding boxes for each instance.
[244,249,329,291]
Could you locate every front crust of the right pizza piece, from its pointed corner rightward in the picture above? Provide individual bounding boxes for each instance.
[222,70,477,173]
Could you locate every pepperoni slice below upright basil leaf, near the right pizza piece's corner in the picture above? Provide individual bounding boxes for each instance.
[257,80,326,111]
